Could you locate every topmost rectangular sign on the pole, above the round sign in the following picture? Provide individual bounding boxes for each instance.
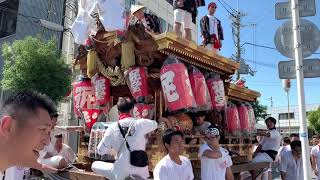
[275,0,316,20]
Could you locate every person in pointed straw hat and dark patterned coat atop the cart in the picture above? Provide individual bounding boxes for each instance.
[130,5,160,34]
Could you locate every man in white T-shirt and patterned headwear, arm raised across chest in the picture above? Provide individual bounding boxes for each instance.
[199,125,234,180]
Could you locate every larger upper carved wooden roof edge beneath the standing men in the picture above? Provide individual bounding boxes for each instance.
[154,32,240,75]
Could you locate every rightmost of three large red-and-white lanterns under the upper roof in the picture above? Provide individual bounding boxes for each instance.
[206,74,226,111]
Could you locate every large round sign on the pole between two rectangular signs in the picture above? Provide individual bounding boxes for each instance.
[274,19,320,59]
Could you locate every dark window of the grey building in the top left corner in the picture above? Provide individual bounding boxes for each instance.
[0,0,19,38]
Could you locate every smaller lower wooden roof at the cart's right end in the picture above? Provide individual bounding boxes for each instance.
[227,84,261,102]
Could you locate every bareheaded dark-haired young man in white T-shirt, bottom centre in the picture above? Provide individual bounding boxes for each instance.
[153,129,194,180]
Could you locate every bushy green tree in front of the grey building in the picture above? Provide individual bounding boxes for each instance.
[1,37,71,103]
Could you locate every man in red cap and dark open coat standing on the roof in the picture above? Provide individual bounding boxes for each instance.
[200,2,224,53]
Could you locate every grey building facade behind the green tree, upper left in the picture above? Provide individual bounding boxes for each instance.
[0,0,65,79]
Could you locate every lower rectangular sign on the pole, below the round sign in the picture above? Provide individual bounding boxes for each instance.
[278,59,320,79]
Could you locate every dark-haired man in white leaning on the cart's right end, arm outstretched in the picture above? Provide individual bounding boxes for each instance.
[252,117,281,180]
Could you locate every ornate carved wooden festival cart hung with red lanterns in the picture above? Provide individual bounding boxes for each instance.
[56,26,268,180]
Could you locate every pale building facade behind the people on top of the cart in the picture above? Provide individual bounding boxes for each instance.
[125,0,198,42]
